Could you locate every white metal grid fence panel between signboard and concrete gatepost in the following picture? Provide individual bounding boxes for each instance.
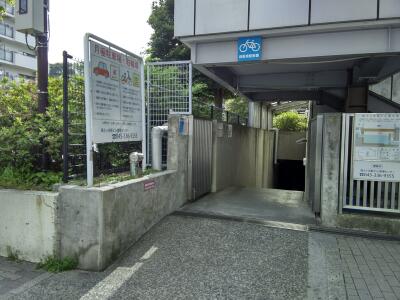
[147,61,192,164]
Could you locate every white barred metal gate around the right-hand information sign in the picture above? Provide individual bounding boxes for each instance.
[340,114,400,213]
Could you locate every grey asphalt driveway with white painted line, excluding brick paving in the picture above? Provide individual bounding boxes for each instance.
[3,216,308,299]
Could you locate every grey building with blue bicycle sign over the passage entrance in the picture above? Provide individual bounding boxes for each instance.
[175,0,400,234]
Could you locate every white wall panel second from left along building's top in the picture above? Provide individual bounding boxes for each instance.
[196,0,248,35]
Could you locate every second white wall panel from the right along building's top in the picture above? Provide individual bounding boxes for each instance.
[311,0,378,24]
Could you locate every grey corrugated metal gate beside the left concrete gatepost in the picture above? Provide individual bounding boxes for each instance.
[188,119,213,200]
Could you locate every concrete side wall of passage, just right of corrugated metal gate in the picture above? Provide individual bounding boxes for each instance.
[212,122,274,192]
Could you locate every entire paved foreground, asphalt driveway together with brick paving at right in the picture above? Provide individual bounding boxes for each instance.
[0,216,400,300]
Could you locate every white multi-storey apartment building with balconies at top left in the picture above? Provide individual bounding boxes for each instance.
[0,0,37,80]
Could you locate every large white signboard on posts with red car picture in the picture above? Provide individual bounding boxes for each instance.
[84,33,146,187]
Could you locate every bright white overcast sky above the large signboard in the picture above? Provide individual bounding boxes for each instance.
[49,0,152,63]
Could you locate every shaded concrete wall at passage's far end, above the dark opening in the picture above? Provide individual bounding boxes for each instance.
[278,131,307,160]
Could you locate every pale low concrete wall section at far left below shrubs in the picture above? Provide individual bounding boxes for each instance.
[0,190,58,262]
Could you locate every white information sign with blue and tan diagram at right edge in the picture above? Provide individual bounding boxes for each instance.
[353,113,400,182]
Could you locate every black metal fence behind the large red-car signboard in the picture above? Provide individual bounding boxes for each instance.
[63,52,142,182]
